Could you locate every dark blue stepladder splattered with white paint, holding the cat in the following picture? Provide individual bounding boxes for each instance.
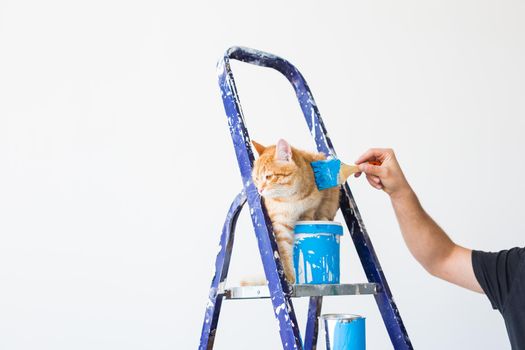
[199,47,413,350]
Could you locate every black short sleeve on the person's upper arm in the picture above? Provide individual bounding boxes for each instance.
[472,248,525,311]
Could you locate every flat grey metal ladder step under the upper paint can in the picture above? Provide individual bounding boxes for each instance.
[220,283,378,299]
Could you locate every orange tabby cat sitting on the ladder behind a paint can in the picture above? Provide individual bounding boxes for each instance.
[244,139,339,285]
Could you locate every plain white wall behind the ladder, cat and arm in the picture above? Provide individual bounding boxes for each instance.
[0,0,525,349]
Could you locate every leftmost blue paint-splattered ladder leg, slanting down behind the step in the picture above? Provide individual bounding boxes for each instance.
[199,191,246,350]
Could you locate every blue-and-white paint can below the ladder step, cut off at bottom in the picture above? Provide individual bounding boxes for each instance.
[320,314,366,350]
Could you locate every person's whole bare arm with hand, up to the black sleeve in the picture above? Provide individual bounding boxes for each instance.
[356,149,483,293]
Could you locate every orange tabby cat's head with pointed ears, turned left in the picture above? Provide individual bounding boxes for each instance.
[252,140,301,198]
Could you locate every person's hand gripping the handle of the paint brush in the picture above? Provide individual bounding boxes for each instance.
[355,148,412,198]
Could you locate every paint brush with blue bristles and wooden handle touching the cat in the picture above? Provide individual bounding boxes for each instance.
[310,158,381,191]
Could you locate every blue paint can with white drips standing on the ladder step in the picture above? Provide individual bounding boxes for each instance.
[293,221,343,284]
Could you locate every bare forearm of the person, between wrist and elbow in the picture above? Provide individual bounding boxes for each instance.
[391,188,456,278]
